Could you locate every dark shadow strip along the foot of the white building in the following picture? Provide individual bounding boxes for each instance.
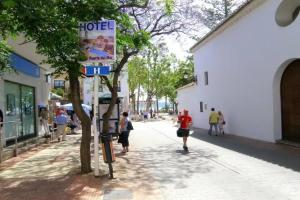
[191,129,300,172]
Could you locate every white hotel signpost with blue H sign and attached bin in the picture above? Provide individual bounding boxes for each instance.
[79,20,116,178]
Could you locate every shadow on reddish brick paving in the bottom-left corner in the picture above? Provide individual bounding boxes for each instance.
[0,174,102,200]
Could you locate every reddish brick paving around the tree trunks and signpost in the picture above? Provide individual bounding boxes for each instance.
[0,131,162,200]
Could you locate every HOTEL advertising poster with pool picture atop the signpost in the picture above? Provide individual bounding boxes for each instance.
[79,20,116,63]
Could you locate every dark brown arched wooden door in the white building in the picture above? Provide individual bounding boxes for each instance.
[281,59,300,142]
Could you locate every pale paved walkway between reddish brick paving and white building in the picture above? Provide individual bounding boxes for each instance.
[130,122,300,200]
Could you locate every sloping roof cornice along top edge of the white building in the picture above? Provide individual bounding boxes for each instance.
[190,0,267,53]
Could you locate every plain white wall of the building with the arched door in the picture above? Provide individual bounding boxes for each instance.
[178,0,300,142]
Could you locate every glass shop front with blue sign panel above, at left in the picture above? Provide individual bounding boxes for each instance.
[0,54,49,146]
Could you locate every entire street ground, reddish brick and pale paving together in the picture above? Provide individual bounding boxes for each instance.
[0,120,300,200]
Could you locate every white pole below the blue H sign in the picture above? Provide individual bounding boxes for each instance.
[93,75,99,176]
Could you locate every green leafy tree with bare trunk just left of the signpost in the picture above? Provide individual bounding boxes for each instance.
[0,0,152,173]
